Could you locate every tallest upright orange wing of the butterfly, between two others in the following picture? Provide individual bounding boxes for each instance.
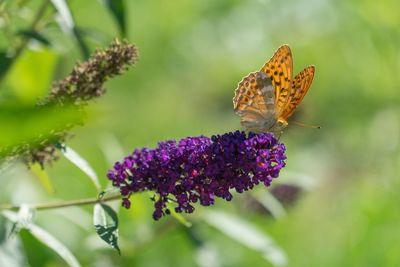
[261,45,293,114]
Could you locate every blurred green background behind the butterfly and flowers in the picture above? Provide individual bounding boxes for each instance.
[0,0,400,267]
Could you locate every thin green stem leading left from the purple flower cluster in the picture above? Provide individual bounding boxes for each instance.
[0,195,122,210]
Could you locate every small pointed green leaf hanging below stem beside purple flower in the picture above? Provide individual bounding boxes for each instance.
[93,204,121,254]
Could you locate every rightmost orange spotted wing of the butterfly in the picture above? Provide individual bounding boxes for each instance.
[278,66,315,121]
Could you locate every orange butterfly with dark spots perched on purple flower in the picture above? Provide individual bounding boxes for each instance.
[233,45,315,135]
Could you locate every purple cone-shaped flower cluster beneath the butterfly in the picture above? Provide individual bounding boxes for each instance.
[107,131,286,220]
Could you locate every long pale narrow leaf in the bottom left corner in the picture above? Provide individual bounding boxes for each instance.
[1,208,81,267]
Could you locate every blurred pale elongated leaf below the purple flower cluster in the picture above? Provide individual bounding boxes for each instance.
[204,211,288,266]
